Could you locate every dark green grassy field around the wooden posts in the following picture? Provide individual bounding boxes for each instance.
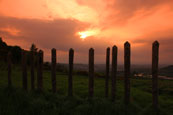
[0,68,173,115]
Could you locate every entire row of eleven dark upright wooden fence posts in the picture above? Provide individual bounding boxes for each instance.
[4,41,159,109]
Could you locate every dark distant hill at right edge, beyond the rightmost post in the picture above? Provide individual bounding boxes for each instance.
[159,65,173,77]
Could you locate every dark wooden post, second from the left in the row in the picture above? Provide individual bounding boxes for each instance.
[22,51,28,90]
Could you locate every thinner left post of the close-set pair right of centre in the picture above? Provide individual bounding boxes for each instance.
[105,48,110,98]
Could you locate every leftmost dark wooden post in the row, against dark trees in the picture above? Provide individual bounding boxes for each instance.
[7,52,12,87]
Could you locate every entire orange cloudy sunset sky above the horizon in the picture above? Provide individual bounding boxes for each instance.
[0,0,173,64]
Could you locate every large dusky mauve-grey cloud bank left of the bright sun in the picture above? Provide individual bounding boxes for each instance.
[0,17,110,63]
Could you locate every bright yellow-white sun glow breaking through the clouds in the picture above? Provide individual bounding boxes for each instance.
[78,30,99,40]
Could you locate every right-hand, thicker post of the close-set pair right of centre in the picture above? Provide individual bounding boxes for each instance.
[111,46,118,101]
